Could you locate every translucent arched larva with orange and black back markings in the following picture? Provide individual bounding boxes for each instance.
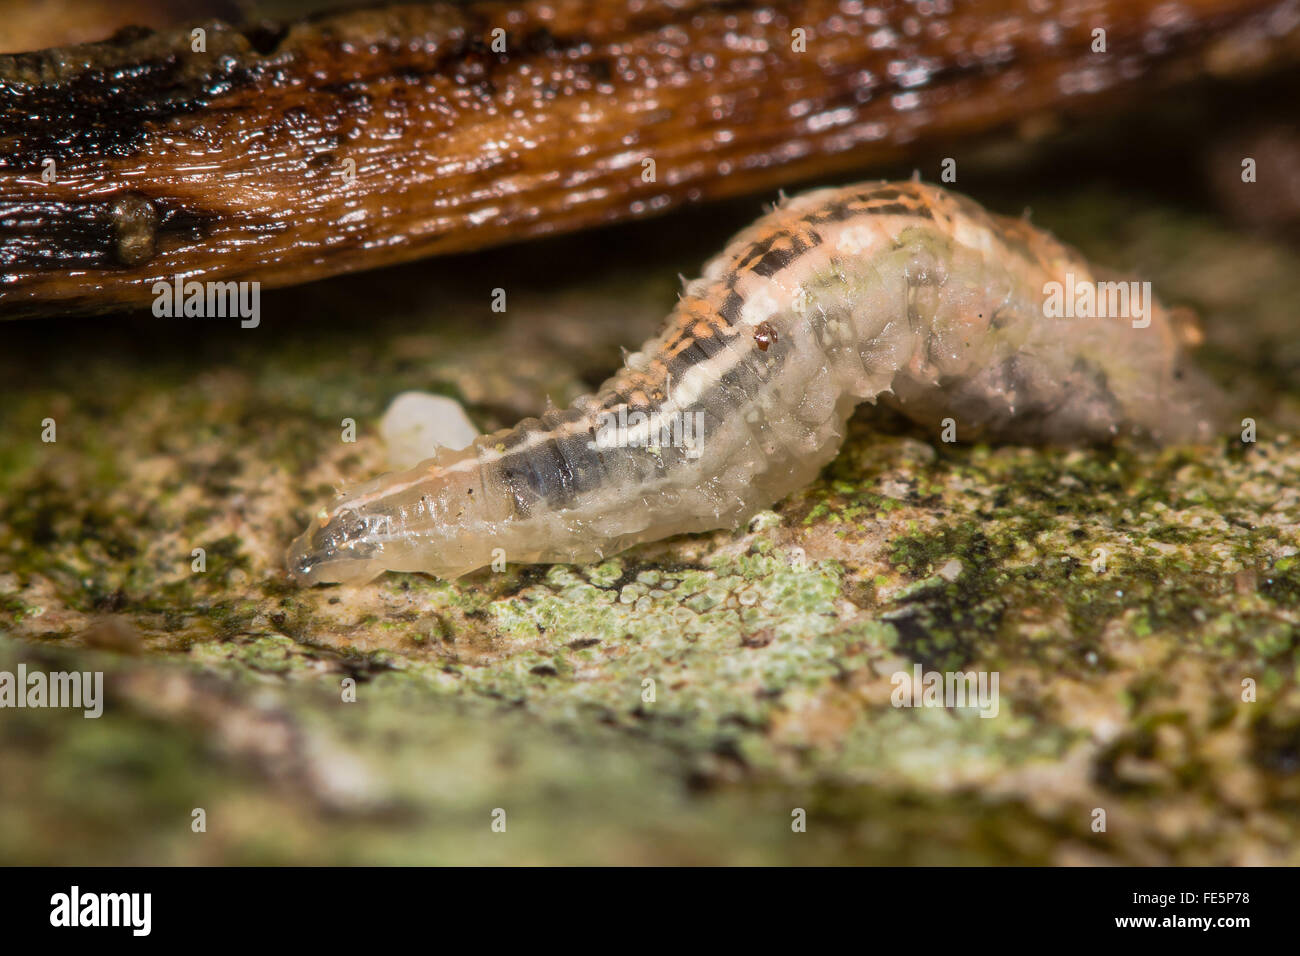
[289,182,1213,583]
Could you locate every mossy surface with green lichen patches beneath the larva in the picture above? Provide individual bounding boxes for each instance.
[0,171,1300,864]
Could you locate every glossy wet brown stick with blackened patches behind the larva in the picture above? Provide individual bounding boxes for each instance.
[0,0,1300,316]
